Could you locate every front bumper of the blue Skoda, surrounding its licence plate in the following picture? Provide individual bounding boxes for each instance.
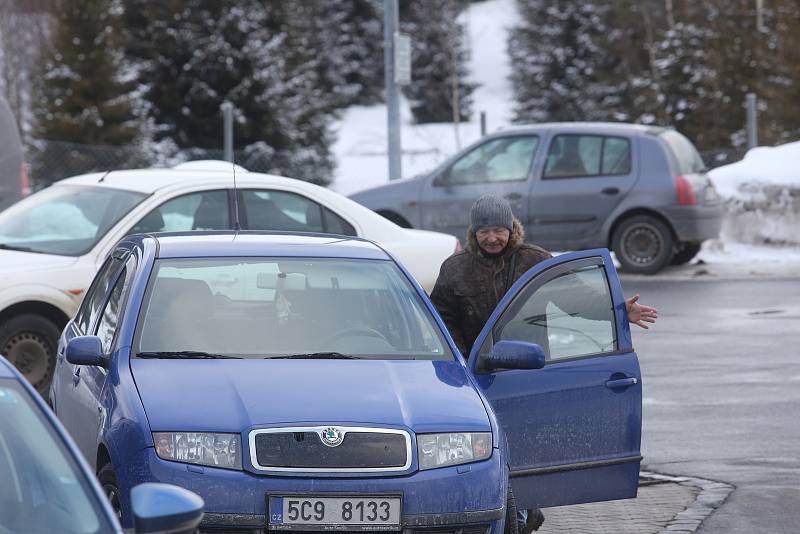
[117,448,508,534]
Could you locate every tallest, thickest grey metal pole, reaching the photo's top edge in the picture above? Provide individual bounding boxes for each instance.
[383,0,402,180]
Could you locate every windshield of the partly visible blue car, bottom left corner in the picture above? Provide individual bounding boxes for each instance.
[0,379,116,534]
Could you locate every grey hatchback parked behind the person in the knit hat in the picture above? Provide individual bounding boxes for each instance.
[350,122,723,274]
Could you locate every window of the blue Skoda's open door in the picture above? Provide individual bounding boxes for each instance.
[494,265,617,361]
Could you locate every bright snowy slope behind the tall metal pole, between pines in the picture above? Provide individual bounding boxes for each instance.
[331,0,516,195]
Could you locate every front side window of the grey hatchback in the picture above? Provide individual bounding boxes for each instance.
[444,136,539,185]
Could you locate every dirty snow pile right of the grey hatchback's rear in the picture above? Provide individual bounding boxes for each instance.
[709,142,800,250]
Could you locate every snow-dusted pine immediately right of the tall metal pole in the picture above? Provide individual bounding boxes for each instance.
[400,0,475,123]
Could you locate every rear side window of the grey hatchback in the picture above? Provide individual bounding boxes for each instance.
[544,135,631,178]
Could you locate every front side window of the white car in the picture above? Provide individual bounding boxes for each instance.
[130,190,230,234]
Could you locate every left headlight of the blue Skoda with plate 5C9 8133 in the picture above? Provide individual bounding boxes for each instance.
[153,432,242,469]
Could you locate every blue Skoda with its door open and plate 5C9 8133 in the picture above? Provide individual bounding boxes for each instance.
[51,232,641,534]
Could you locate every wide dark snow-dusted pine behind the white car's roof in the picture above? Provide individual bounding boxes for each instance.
[119,0,333,183]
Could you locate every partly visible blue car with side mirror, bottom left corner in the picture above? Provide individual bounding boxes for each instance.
[0,356,203,534]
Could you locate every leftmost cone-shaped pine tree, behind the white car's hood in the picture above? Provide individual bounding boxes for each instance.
[34,0,138,180]
